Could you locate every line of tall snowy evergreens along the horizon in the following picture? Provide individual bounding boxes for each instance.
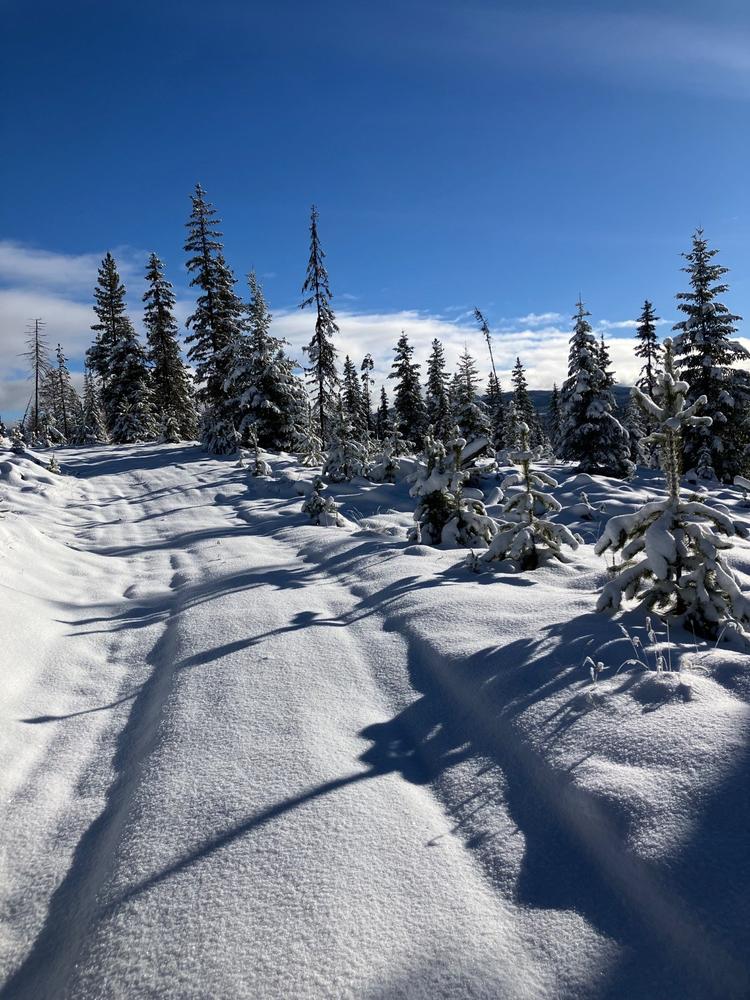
[2,185,750,481]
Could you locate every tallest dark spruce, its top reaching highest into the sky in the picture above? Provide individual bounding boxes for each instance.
[185,184,245,455]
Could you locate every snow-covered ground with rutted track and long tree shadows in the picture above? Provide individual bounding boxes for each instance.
[0,445,750,1000]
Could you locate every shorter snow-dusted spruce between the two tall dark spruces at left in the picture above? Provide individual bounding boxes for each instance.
[109,319,158,444]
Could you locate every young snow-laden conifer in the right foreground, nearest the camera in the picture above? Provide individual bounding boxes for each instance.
[595,340,750,638]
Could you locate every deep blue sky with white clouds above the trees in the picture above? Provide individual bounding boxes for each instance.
[0,0,750,414]
